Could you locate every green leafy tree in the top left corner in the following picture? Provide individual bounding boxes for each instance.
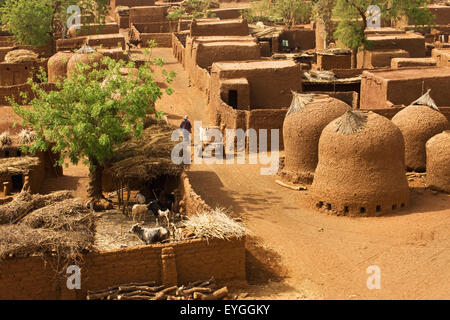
[0,0,108,52]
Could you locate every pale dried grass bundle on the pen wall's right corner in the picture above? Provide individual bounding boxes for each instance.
[185,208,248,239]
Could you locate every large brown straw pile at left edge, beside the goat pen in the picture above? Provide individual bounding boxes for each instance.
[0,191,95,264]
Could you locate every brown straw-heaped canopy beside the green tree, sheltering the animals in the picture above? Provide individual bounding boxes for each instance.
[106,120,184,181]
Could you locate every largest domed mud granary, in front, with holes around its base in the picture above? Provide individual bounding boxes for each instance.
[311,111,409,216]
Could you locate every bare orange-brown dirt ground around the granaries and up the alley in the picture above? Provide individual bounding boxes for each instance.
[39,48,450,299]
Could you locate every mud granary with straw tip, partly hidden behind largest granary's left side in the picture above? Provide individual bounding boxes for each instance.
[281,92,350,183]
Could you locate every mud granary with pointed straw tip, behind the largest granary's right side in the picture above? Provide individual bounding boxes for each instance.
[392,105,449,172]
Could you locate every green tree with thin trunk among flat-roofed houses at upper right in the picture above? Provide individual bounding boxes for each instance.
[333,0,433,67]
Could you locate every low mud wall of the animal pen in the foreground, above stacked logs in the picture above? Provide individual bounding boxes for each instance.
[0,239,245,299]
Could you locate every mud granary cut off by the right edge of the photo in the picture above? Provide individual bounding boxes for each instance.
[426,130,450,193]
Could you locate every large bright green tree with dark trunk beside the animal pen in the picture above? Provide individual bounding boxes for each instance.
[12,57,175,202]
